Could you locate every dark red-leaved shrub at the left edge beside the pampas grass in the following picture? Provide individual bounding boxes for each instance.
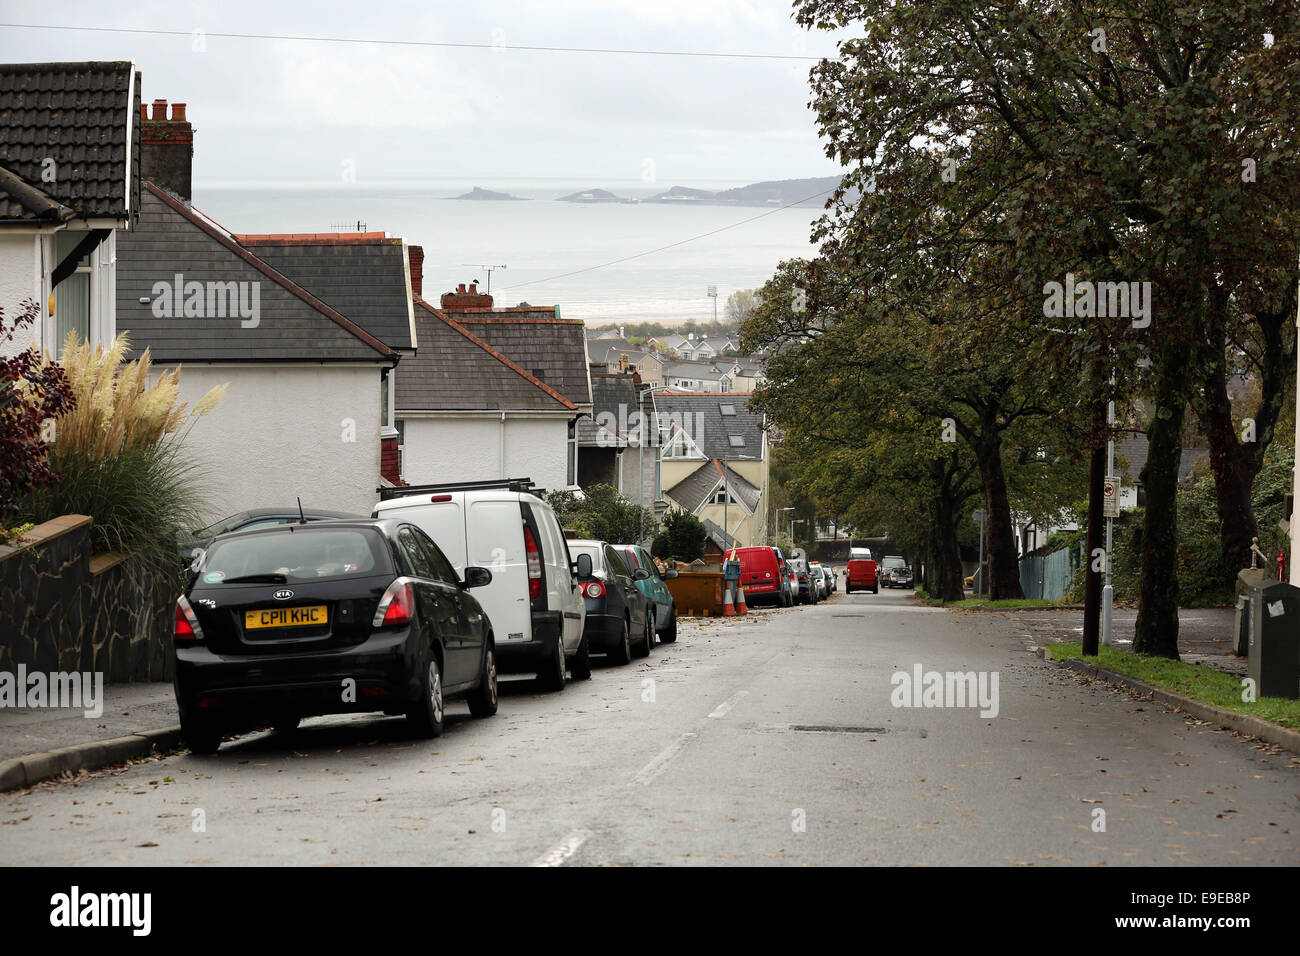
[0,299,75,527]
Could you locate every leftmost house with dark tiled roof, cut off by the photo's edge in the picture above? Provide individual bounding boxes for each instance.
[0,62,139,355]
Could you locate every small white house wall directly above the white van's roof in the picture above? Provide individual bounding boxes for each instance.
[402,412,568,490]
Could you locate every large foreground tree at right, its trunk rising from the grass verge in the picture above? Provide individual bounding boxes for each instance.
[796,0,1300,657]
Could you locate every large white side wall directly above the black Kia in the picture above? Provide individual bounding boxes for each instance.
[163,364,380,520]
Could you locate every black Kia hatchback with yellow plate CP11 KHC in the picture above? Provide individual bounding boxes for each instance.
[176,519,498,753]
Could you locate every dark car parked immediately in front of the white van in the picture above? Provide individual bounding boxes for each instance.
[569,538,654,663]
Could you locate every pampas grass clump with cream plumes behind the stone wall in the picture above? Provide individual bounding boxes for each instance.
[21,336,226,580]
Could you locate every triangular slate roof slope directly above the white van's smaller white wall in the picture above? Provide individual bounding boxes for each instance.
[394,297,575,415]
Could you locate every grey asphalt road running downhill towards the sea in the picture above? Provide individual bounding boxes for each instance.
[0,591,1300,866]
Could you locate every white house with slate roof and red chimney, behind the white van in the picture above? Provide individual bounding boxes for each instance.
[395,280,592,489]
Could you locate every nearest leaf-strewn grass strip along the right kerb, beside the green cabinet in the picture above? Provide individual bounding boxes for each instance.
[1047,641,1300,730]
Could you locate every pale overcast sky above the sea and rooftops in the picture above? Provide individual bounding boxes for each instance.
[0,0,837,185]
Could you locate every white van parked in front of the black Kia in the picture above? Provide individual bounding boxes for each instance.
[373,481,592,691]
